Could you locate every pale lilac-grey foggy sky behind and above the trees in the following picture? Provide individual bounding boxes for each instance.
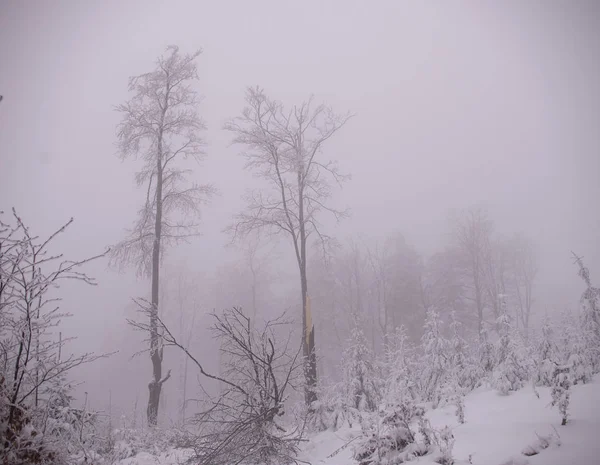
[0,0,600,420]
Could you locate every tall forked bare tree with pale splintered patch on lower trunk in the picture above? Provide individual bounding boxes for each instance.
[225,88,351,404]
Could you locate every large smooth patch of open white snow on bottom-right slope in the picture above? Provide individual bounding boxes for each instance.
[429,377,600,465]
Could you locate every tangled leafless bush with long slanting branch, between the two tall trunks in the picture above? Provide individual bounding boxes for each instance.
[130,300,302,465]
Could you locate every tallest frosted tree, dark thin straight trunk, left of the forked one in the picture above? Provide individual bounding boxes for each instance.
[112,46,215,425]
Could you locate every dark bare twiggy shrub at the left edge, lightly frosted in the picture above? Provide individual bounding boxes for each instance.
[0,210,108,463]
